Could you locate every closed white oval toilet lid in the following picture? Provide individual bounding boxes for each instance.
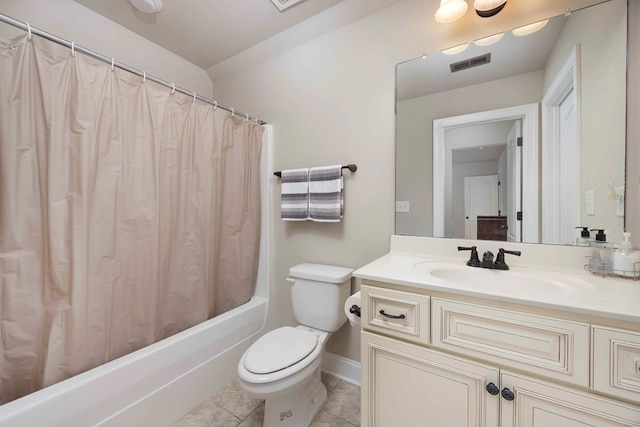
[244,326,318,374]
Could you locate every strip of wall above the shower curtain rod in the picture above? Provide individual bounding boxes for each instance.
[0,0,213,97]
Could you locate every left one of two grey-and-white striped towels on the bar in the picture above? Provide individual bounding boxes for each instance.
[280,168,309,221]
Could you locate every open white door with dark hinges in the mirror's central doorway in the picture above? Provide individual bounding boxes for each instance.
[506,120,524,242]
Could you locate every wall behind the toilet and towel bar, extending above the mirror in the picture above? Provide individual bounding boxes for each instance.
[208,0,588,360]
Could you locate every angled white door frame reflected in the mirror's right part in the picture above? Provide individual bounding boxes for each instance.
[541,45,582,243]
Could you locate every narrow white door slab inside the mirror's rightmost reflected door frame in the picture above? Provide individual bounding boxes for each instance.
[555,90,581,244]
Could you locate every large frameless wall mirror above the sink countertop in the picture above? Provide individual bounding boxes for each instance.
[395,0,627,245]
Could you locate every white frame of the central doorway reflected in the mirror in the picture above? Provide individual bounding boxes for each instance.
[433,103,539,243]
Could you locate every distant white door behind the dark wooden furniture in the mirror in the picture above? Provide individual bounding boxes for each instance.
[464,175,498,239]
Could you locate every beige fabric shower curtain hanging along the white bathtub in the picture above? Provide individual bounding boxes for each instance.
[0,36,263,403]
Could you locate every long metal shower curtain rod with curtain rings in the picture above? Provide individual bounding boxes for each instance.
[0,13,267,125]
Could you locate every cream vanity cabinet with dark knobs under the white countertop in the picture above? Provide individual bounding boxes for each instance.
[361,281,640,427]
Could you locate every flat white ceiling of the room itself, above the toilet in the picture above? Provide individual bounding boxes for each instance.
[75,0,401,69]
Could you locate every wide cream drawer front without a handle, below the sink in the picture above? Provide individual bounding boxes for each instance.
[431,298,589,387]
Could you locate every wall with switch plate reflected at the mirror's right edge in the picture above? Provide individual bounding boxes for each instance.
[544,0,627,242]
